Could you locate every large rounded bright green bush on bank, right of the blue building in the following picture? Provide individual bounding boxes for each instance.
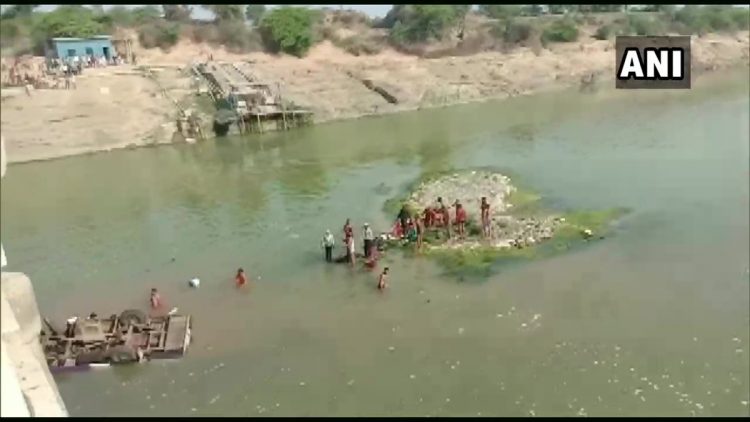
[260,6,317,57]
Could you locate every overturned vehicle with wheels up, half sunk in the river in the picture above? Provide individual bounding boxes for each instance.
[41,309,192,372]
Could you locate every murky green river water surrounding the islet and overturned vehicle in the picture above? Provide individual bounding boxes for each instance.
[2,71,750,416]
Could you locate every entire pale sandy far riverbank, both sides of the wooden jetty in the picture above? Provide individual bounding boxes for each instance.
[2,31,750,162]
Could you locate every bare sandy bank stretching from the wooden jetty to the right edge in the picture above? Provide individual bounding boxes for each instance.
[242,28,750,121]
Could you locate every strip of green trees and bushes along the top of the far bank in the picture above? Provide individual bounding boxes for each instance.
[0,4,750,56]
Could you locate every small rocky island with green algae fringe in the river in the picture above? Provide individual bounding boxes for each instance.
[385,169,626,275]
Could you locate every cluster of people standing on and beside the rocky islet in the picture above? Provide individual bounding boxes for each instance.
[321,197,492,290]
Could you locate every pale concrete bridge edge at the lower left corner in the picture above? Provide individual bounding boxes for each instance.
[0,136,68,417]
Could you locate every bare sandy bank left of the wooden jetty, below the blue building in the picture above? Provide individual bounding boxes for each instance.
[2,66,194,162]
